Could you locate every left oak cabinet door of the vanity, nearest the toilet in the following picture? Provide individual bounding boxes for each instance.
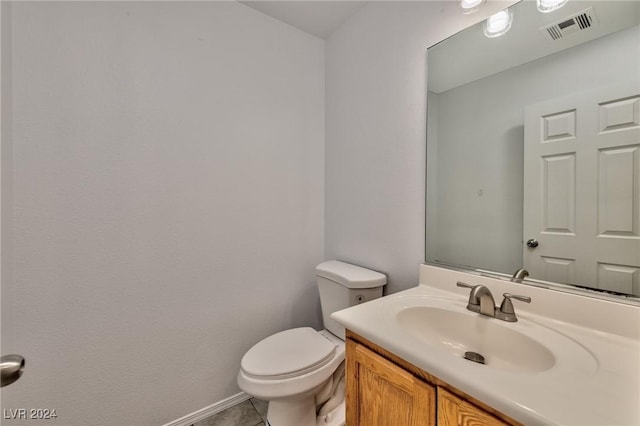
[346,340,436,426]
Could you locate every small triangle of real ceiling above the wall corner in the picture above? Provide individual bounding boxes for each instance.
[240,0,367,39]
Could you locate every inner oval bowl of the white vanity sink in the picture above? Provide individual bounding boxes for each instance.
[396,306,556,373]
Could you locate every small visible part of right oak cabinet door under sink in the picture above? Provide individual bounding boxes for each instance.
[438,387,508,426]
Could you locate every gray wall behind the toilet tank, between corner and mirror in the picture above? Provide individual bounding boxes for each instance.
[325,1,515,292]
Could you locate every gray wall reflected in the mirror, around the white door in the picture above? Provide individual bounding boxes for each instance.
[427,26,640,273]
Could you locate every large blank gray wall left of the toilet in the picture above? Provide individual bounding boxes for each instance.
[2,2,324,425]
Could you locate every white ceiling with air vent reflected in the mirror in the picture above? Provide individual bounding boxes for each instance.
[427,0,640,93]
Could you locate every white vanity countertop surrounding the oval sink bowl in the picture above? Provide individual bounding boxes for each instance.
[332,266,640,426]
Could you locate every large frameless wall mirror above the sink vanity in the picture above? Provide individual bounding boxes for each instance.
[426,0,640,303]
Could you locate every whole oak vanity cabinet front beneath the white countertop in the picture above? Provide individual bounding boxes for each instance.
[346,330,520,426]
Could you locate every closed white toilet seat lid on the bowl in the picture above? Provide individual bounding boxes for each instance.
[240,327,336,380]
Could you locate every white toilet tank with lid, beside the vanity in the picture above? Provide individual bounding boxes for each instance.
[316,260,387,340]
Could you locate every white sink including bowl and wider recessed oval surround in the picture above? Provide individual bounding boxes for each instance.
[378,296,598,374]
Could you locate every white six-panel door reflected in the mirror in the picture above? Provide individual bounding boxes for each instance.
[523,84,640,296]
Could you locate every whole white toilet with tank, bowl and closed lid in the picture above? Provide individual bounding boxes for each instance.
[238,260,387,426]
